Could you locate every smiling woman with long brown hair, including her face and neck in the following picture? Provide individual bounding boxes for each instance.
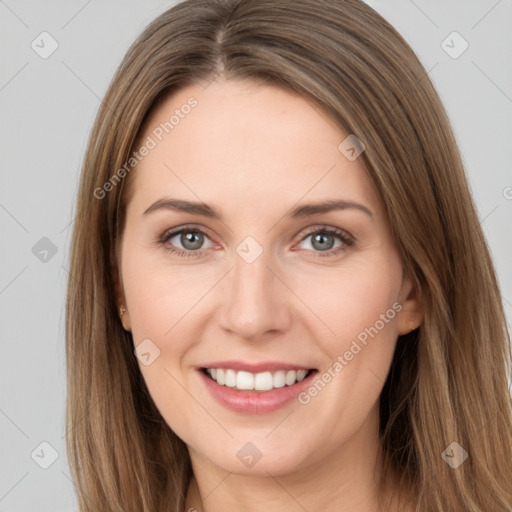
[66,0,512,512]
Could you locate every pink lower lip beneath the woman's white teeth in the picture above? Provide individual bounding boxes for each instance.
[198,370,317,414]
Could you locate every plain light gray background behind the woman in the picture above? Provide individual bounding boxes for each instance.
[0,0,512,512]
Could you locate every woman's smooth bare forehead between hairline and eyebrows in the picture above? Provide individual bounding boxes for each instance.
[126,80,378,219]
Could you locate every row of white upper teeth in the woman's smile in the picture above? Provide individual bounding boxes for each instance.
[206,368,308,391]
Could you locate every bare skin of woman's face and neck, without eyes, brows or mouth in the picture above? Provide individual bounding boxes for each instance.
[117,78,422,512]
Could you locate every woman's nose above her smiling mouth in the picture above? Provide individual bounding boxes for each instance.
[219,251,292,341]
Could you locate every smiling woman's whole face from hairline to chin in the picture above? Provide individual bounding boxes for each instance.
[118,81,419,475]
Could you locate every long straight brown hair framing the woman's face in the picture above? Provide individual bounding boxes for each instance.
[66,0,512,512]
